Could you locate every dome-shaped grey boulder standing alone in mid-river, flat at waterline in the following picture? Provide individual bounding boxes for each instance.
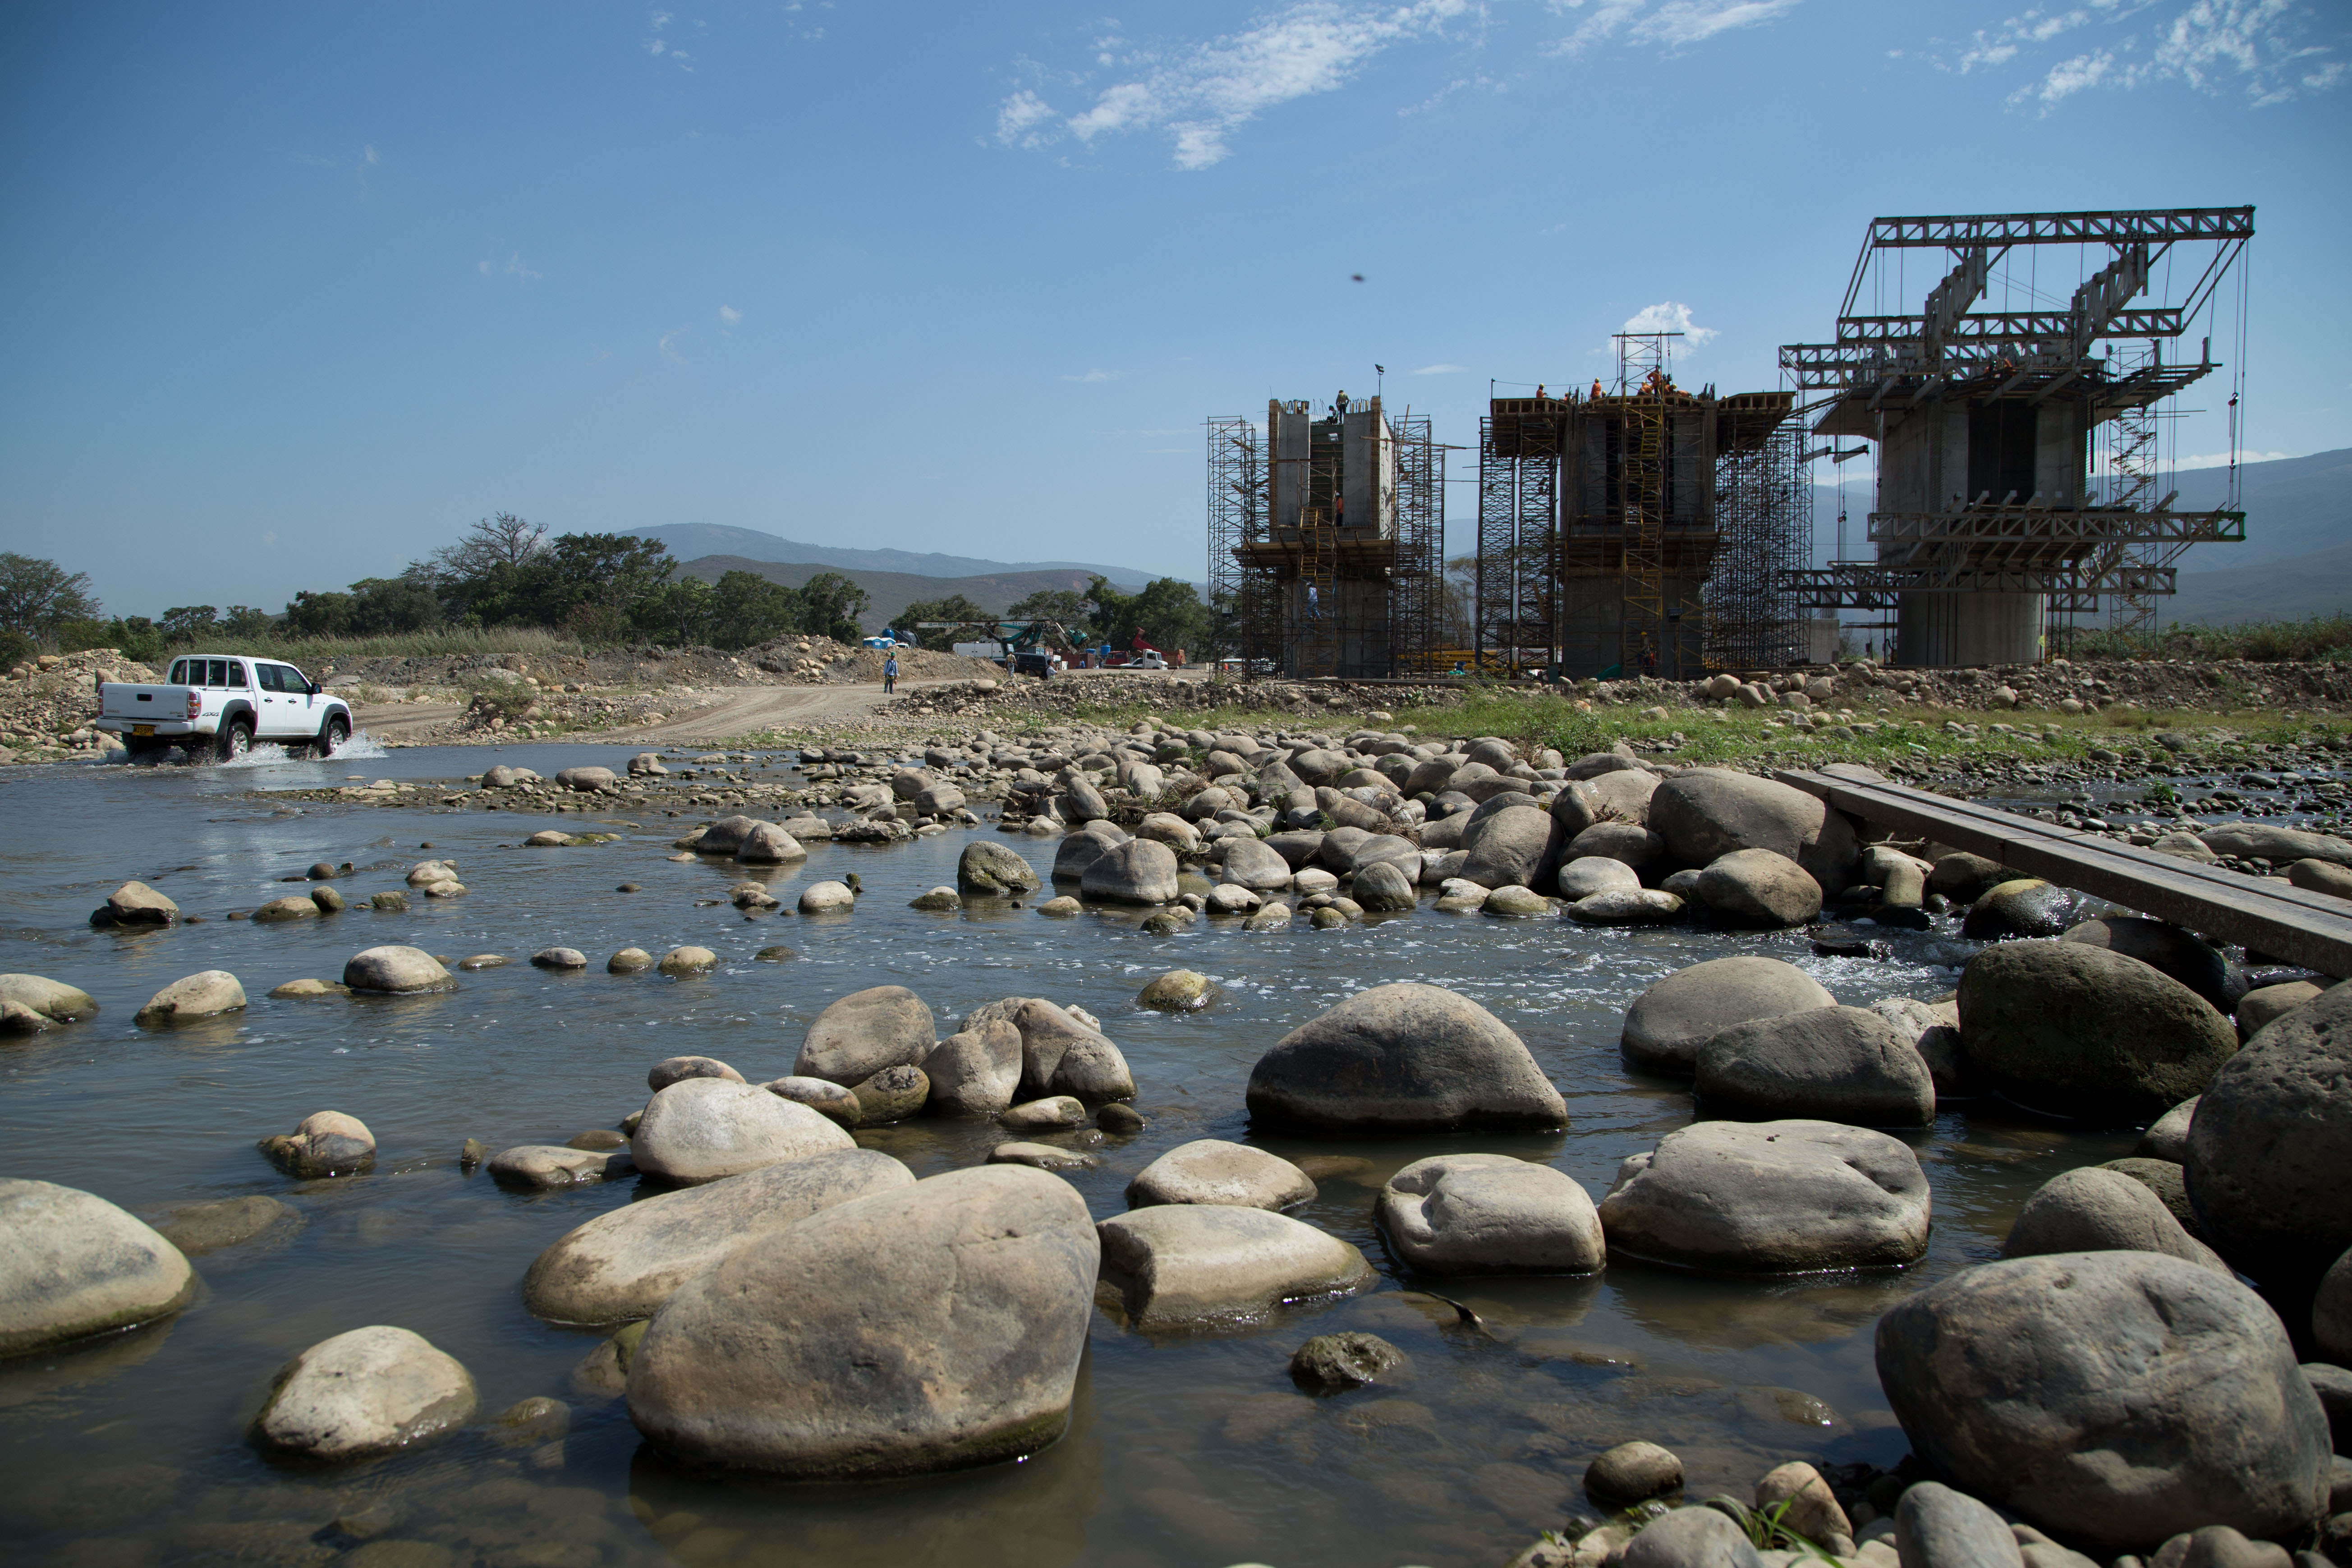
[1246,983,1566,1133]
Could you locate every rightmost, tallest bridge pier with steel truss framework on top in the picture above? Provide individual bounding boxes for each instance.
[1781,207,2253,665]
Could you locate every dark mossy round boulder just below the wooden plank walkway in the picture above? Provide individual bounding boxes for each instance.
[1959,943,2237,1126]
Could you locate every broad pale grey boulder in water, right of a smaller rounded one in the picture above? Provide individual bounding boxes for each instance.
[1599,1122,1929,1274]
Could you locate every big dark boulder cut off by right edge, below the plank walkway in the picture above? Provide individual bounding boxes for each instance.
[2185,985,2352,1283]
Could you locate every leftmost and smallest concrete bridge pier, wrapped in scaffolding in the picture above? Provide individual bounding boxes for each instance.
[1207,393,1444,680]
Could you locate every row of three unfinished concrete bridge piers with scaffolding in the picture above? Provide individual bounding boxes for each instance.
[1209,207,2253,680]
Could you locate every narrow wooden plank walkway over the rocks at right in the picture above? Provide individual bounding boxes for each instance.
[1773,766,2352,978]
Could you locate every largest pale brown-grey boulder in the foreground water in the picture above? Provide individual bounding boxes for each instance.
[628,1166,1101,1479]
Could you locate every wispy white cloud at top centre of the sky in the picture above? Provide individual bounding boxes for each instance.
[997,0,1472,169]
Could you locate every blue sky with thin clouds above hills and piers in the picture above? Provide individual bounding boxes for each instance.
[0,0,2352,614]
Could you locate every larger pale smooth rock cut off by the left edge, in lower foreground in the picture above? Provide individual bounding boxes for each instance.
[0,1178,195,1356]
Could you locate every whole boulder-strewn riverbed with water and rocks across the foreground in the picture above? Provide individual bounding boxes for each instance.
[0,738,2352,1568]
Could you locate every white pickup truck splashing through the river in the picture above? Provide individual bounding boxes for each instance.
[96,653,350,762]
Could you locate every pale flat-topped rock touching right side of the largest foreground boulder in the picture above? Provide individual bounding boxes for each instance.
[1096,1204,1374,1330]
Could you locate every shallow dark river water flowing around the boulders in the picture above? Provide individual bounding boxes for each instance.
[0,745,2201,1568]
